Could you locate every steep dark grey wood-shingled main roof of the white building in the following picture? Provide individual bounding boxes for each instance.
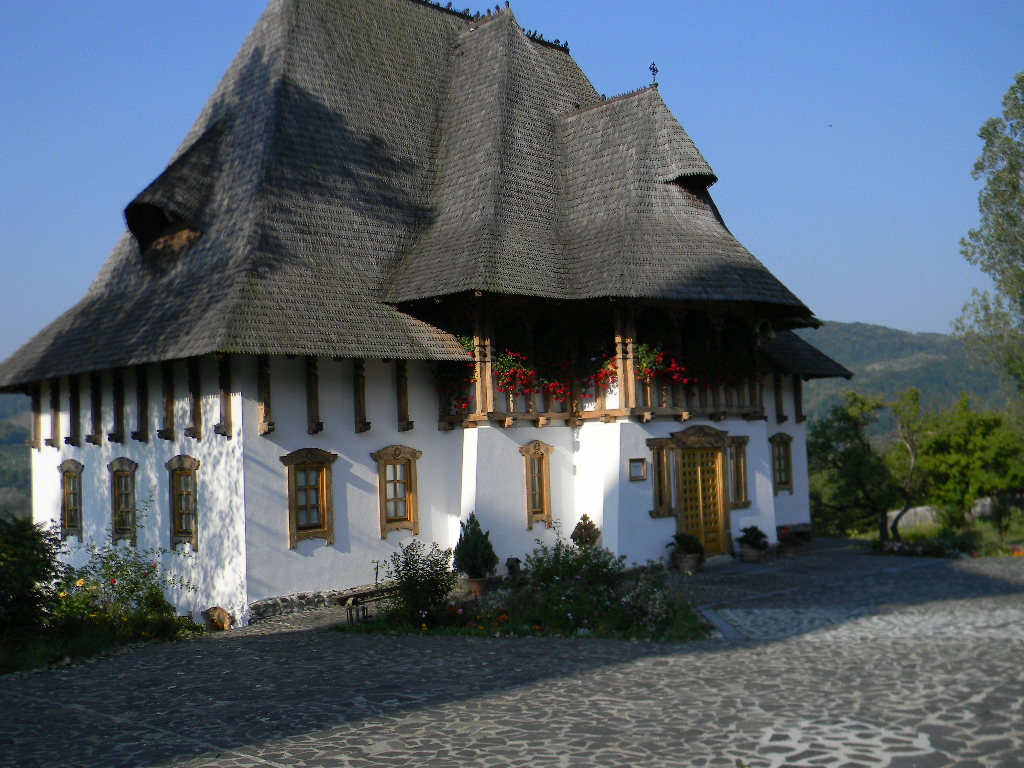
[0,0,811,386]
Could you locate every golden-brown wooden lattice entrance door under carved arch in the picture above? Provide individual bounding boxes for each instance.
[676,449,722,554]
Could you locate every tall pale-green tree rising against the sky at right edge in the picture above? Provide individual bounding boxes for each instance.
[955,72,1024,393]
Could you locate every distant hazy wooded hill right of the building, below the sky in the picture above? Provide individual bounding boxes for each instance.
[798,322,1007,419]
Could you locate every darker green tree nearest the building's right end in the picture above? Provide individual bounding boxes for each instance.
[807,390,900,541]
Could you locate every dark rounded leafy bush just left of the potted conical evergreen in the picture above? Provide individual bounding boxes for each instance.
[387,539,458,623]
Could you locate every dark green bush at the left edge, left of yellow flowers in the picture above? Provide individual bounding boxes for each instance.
[0,517,65,631]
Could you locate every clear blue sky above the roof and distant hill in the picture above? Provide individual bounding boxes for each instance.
[0,0,1024,357]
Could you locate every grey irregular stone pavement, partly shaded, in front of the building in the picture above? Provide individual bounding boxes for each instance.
[0,543,1024,768]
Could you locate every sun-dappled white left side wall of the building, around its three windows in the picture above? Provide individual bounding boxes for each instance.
[31,358,247,617]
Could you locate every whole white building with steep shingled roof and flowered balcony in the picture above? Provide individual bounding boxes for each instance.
[0,0,849,616]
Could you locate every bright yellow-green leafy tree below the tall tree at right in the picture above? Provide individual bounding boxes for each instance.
[921,395,1024,529]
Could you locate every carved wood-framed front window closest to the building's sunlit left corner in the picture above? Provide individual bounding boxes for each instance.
[281,449,338,549]
